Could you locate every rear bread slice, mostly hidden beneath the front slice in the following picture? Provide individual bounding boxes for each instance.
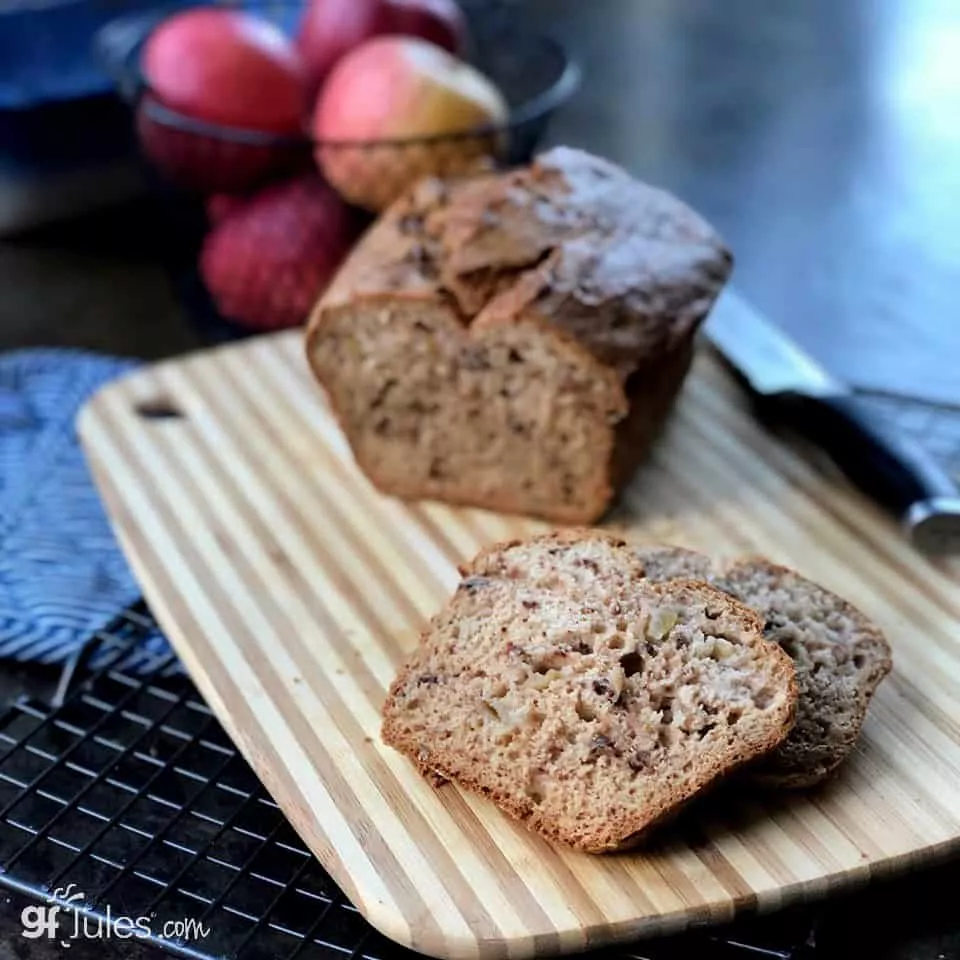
[636,547,891,787]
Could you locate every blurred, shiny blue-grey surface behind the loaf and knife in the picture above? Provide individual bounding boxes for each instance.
[531,0,960,402]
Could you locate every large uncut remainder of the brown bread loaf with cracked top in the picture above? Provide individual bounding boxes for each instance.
[307,148,731,522]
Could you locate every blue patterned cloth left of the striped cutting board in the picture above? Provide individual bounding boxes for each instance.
[0,350,169,669]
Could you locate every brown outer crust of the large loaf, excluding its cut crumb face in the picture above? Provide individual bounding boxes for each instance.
[306,148,732,523]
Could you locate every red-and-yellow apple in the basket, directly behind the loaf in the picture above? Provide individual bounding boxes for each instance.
[311,36,508,210]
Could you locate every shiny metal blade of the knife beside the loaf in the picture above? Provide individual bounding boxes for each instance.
[706,290,844,396]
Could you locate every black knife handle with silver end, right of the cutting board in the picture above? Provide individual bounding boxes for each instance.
[762,393,960,553]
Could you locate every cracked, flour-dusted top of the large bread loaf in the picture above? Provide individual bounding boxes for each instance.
[321,147,732,379]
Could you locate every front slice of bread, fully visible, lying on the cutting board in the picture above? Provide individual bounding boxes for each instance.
[383,531,797,852]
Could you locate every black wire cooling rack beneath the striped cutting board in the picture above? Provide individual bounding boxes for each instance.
[0,604,816,960]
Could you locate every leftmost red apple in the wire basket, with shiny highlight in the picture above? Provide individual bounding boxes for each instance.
[136,7,306,192]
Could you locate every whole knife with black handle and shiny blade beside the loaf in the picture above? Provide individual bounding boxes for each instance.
[706,291,960,553]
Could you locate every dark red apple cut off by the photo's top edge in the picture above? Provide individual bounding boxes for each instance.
[296,0,466,91]
